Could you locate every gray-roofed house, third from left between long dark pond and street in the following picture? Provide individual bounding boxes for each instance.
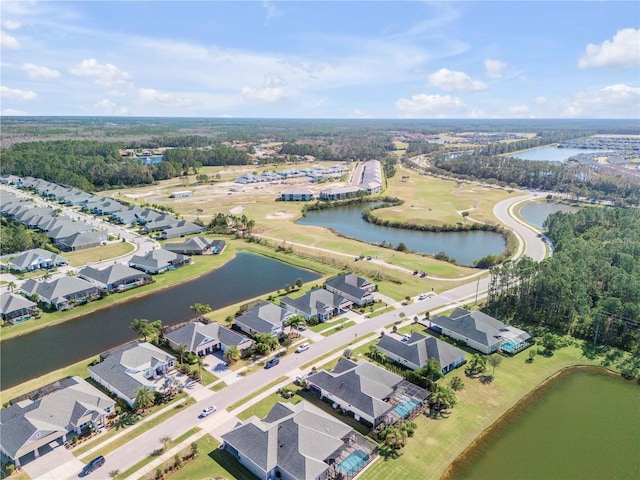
[165,322,255,355]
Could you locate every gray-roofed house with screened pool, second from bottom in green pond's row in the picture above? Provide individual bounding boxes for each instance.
[305,358,431,426]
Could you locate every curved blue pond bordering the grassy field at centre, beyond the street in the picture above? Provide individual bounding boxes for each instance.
[296,204,506,265]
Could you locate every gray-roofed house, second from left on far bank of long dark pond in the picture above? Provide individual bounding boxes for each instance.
[20,276,101,310]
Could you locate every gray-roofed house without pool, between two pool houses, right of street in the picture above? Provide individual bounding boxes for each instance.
[376,333,464,375]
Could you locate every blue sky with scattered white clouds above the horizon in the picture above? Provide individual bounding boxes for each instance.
[0,0,640,118]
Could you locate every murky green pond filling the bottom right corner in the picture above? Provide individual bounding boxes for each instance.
[443,368,640,480]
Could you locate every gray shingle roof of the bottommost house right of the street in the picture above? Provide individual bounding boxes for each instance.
[222,401,351,480]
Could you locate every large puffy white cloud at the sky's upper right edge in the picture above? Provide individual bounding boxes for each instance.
[578,28,640,68]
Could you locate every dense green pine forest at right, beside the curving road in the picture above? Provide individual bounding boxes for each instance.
[487,207,640,353]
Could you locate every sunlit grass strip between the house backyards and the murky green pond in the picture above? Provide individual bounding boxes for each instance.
[361,346,632,480]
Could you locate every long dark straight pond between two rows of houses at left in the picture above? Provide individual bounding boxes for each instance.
[0,253,320,390]
